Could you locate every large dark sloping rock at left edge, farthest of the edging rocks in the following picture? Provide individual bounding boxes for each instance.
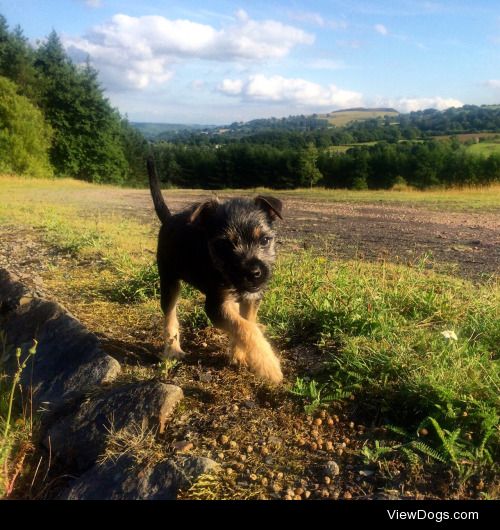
[0,269,121,410]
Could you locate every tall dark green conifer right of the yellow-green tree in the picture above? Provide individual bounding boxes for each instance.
[35,31,128,182]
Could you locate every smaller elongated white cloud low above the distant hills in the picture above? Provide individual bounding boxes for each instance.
[218,74,362,108]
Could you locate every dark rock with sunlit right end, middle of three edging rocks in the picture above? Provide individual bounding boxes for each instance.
[43,381,183,471]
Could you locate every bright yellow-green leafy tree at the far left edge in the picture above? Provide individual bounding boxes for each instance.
[0,77,52,177]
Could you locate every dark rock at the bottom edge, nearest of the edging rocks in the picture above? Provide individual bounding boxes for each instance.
[59,456,218,500]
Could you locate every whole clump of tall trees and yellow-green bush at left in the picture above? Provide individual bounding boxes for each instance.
[0,15,147,183]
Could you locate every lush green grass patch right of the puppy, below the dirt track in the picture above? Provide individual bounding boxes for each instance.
[262,253,500,468]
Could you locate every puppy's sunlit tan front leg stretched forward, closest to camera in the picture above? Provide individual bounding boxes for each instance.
[205,296,283,384]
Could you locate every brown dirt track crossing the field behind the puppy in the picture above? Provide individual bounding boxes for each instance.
[106,190,500,280]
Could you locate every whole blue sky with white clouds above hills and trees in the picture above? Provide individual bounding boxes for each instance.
[0,0,500,124]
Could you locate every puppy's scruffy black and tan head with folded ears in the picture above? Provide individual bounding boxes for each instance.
[191,195,282,294]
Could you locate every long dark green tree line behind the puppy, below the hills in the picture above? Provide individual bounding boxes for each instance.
[153,140,500,189]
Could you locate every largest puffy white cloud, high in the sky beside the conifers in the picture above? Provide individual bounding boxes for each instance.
[64,10,314,90]
